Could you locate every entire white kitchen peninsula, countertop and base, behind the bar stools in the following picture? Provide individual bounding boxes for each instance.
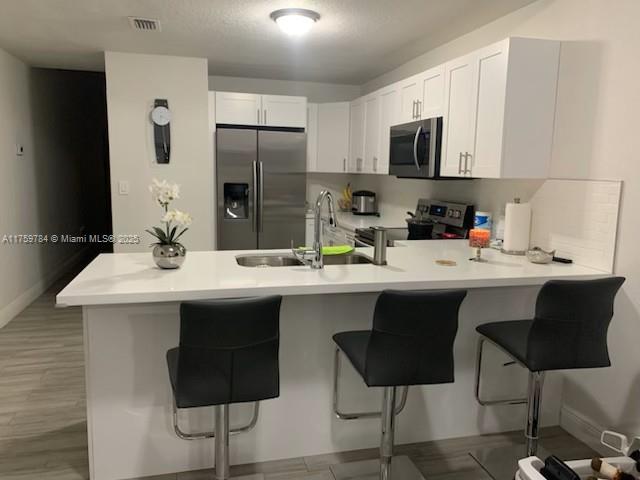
[57,240,607,480]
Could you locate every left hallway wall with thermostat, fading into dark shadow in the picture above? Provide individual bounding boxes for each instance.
[0,50,88,326]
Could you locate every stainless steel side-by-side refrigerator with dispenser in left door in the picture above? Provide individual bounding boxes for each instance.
[216,127,307,250]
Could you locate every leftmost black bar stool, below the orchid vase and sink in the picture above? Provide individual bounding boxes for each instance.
[167,295,282,480]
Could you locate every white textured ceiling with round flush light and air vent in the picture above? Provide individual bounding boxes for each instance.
[0,0,533,84]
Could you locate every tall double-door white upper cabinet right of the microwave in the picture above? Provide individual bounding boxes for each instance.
[441,38,560,178]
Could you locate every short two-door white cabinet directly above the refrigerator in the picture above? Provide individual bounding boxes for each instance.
[216,92,307,128]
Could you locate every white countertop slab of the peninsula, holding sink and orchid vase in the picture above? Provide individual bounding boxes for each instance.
[57,240,608,306]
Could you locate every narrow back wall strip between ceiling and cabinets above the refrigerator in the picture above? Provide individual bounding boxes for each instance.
[209,75,360,103]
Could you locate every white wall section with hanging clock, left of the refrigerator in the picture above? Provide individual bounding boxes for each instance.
[105,52,214,252]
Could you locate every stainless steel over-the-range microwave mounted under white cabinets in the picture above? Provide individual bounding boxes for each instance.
[389,117,442,179]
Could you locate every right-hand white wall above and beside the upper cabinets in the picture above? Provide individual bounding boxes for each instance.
[363,0,640,446]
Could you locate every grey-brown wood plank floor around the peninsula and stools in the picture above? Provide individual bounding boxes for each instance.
[0,278,595,480]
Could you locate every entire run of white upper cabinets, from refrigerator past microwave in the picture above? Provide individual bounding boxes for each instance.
[215,37,560,178]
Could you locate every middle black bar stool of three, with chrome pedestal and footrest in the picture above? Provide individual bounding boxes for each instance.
[331,290,467,480]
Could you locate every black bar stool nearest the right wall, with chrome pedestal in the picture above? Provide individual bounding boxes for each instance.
[475,277,625,478]
